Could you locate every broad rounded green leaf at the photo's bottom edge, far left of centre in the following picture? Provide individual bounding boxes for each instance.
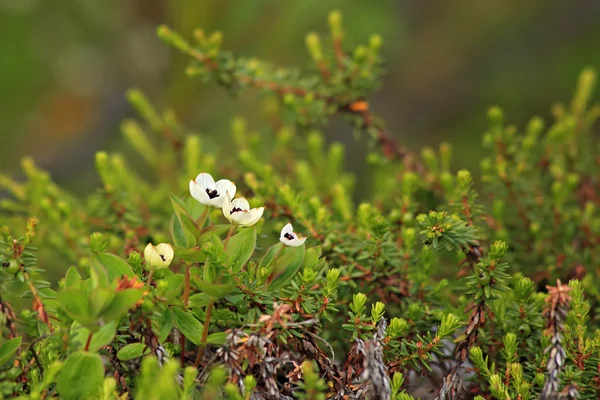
[56,351,104,400]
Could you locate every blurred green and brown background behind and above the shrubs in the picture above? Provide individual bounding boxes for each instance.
[0,0,600,191]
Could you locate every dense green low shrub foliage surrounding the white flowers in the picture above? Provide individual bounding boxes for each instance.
[0,8,600,400]
